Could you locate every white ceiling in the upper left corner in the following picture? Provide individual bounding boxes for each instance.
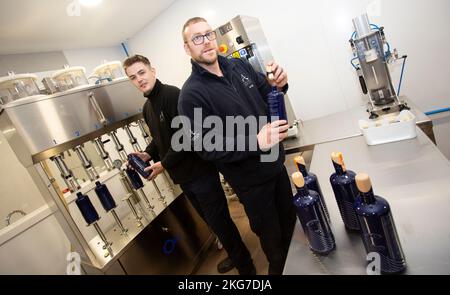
[0,0,175,54]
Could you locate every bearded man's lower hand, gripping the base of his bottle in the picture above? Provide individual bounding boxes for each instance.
[257,120,289,152]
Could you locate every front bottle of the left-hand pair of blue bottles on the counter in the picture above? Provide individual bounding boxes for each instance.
[292,172,336,255]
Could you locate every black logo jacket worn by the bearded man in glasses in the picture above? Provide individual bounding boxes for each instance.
[178,56,288,188]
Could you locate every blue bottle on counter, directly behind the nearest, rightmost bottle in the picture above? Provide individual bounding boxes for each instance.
[330,153,360,231]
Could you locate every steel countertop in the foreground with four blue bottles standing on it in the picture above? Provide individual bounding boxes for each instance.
[284,128,450,275]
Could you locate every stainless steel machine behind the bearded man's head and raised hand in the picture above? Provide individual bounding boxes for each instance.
[215,15,297,126]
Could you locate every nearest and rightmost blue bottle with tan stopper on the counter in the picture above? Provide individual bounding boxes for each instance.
[354,173,406,274]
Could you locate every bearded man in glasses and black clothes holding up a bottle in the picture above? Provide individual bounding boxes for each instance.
[178,17,295,275]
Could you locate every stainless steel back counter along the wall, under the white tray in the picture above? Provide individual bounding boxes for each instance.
[283,97,431,154]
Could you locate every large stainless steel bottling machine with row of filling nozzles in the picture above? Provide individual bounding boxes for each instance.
[0,67,213,274]
